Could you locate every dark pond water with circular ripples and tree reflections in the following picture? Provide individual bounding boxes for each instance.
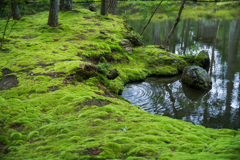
[122,5,240,129]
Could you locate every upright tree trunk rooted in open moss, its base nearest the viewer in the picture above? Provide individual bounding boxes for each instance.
[48,0,59,27]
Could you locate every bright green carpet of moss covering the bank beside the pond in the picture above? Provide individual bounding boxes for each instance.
[0,7,240,160]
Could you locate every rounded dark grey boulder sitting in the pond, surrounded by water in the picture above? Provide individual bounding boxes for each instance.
[182,66,212,90]
